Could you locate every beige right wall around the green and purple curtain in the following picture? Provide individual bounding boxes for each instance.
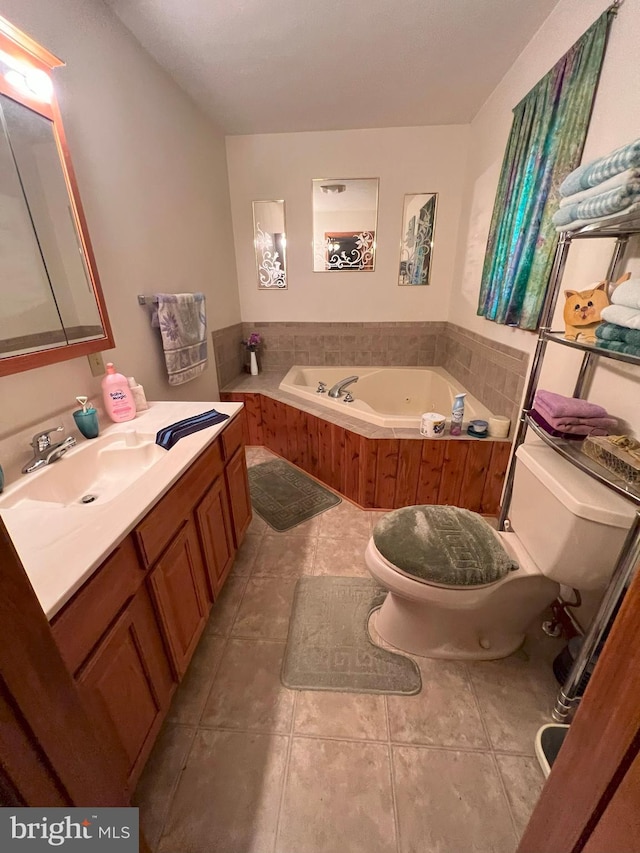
[450,0,640,430]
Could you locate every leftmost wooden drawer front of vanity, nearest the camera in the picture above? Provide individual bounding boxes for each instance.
[51,536,144,672]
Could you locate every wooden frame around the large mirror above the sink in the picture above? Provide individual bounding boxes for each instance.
[0,17,115,376]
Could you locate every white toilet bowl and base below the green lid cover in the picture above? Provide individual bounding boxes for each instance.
[365,540,559,660]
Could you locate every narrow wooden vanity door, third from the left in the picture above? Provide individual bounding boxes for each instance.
[196,477,236,597]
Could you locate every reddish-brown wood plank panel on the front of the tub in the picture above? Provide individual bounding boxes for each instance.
[220,392,511,515]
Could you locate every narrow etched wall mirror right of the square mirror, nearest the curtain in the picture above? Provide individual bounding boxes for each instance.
[398,193,438,285]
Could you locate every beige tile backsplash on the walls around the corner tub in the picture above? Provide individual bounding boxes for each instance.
[213,322,529,424]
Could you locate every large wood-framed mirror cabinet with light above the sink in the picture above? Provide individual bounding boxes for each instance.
[0,18,114,376]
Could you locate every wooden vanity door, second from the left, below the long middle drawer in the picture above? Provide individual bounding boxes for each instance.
[149,520,210,676]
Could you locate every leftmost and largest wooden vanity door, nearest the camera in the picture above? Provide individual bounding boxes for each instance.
[78,587,174,785]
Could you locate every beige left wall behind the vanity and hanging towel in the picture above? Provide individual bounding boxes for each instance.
[0,0,240,464]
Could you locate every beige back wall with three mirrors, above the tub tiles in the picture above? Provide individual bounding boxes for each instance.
[227,125,468,322]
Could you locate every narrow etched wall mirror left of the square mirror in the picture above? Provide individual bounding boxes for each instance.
[253,199,287,290]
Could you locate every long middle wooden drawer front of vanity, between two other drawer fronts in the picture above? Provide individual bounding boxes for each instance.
[135,441,223,566]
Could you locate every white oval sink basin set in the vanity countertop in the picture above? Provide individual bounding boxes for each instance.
[0,430,167,509]
